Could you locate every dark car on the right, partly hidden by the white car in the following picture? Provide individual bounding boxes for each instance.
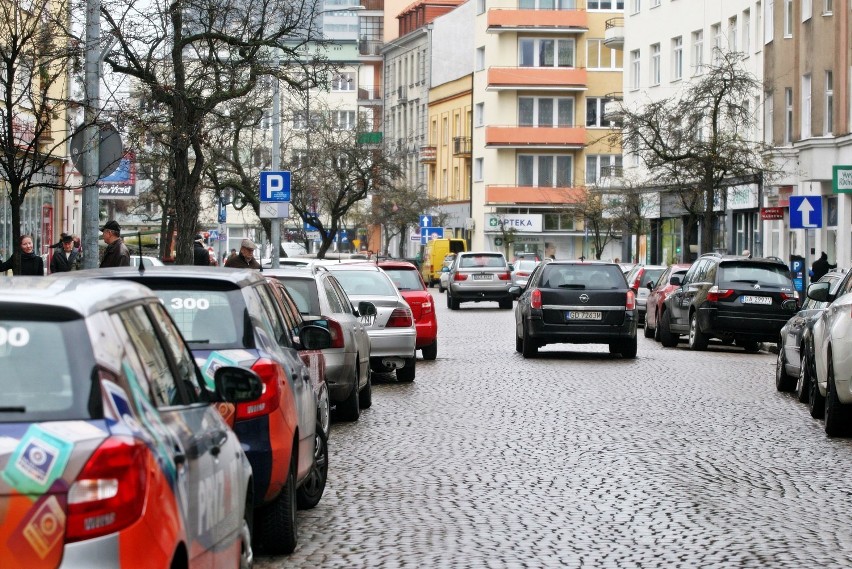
[775,271,844,403]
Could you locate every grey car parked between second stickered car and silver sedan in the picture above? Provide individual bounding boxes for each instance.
[263,266,375,421]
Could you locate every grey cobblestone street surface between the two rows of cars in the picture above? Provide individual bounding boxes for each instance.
[256,296,852,569]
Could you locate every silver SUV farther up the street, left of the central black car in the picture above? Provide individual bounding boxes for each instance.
[447,251,514,310]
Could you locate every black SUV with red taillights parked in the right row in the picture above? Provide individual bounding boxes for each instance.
[659,253,799,352]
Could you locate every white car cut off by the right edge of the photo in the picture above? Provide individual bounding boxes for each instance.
[808,273,852,437]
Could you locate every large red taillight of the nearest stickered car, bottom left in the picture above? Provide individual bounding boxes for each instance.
[65,436,149,542]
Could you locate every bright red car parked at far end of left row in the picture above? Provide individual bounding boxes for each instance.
[378,261,438,360]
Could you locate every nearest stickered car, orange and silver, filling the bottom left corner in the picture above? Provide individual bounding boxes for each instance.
[0,273,262,569]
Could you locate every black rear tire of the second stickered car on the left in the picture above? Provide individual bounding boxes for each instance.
[254,448,299,555]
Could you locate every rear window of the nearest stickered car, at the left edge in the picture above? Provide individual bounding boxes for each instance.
[0,316,95,422]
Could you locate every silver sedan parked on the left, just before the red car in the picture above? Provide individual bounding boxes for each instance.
[326,262,417,382]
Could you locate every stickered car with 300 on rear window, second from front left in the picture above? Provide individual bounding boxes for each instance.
[70,266,331,554]
